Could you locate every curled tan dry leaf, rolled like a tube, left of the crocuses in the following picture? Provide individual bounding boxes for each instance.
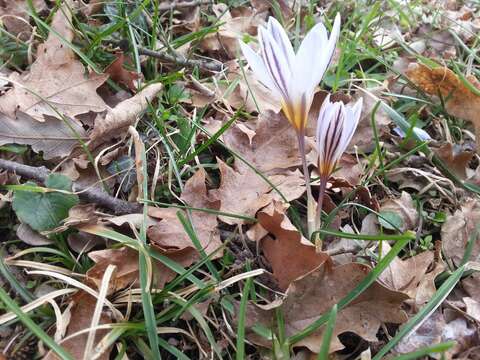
[88,83,163,149]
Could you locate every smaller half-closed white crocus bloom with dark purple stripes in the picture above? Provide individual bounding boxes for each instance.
[317,95,362,180]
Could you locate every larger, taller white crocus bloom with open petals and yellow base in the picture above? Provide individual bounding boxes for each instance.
[240,14,340,133]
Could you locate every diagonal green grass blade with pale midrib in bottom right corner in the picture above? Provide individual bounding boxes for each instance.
[372,266,465,360]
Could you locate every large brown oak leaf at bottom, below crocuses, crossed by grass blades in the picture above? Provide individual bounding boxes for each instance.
[246,263,408,353]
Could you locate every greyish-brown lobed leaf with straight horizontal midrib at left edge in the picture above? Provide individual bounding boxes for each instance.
[0,111,86,160]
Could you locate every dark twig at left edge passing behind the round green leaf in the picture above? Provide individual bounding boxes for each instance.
[0,159,142,215]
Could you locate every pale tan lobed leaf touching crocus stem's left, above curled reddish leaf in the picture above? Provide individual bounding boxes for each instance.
[210,159,305,225]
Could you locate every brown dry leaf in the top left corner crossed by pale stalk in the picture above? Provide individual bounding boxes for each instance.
[0,0,46,40]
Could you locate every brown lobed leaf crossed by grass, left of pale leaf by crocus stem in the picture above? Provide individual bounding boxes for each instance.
[147,169,222,262]
